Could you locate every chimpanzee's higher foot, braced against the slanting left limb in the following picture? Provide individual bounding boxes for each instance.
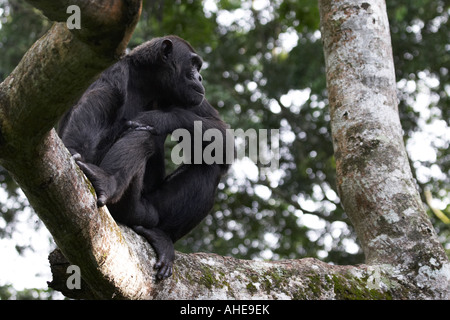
[74,160,114,207]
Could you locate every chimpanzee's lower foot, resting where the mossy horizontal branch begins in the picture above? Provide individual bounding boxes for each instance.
[132,226,175,280]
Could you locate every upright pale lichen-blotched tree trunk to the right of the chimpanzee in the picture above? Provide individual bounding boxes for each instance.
[319,0,450,297]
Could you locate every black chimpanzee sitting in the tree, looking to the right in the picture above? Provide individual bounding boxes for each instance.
[58,36,228,279]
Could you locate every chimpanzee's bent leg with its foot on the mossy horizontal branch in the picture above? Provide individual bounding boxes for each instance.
[133,165,222,279]
